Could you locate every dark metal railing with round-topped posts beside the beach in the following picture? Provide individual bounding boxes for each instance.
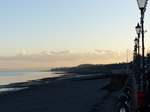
[117,72,137,112]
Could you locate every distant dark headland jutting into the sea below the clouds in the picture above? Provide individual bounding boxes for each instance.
[51,63,131,74]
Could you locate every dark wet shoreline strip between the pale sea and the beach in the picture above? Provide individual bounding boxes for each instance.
[0,72,125,93]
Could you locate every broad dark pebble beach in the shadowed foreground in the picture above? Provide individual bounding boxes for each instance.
[0,74,121,112]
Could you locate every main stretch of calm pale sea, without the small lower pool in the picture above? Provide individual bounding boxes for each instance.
[0,72,63,85]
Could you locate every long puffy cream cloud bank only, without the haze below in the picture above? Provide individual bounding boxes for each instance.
[0,49,132,63]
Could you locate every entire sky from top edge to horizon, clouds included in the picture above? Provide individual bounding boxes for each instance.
[0,0,150,70]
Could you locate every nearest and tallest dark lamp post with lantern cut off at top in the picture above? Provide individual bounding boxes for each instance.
[137,0,148,92]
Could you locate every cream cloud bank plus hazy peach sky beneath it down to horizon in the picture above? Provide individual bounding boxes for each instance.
[0,49,132,70]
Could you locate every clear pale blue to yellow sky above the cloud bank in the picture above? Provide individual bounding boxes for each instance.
[0,0,150,70]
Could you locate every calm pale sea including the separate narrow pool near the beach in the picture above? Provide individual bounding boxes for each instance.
[0,71,65,94]
